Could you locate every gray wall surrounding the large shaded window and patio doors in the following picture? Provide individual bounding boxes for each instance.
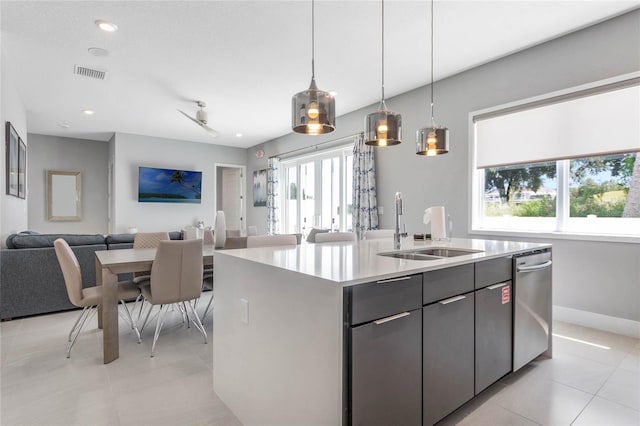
[247,10,640,321]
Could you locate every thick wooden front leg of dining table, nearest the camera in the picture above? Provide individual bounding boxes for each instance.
[101,268,120,364]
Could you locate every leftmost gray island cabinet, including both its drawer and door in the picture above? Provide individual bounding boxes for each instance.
[343,274,422,425]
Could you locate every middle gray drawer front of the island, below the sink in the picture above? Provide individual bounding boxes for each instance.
[422,264,473,305]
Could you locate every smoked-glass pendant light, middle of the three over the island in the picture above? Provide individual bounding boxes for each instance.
[364,0,402,146]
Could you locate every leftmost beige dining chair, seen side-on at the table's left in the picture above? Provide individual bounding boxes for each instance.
[53,238,142,358]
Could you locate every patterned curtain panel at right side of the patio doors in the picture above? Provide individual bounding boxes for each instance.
[353,134,378,240]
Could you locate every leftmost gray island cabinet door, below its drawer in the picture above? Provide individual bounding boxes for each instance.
[351,309,422,426]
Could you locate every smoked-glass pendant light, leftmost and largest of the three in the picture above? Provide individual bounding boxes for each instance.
[291,0,336,135]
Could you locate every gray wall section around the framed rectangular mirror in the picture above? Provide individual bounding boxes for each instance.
[27,133,108,234]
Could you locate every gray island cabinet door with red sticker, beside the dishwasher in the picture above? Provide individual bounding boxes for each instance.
[475,281,513,395]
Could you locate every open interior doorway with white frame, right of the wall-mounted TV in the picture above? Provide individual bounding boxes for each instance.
[214,164,246,235]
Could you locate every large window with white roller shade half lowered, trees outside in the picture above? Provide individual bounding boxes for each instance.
[472,78,640,237]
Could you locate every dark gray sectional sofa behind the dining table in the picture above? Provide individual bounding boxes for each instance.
[0,231,182,320]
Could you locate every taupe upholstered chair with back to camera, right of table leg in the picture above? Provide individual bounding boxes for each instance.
[140,240,207,357]
